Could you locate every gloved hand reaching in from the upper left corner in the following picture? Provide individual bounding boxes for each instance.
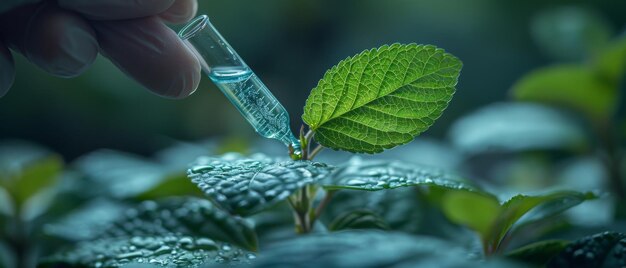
[0,0,200,98]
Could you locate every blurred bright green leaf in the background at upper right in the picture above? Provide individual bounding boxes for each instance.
[512,65,618,122]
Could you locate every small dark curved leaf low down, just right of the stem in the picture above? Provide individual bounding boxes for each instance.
[328,209,390,231]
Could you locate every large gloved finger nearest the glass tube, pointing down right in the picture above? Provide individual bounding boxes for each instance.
[93,17,200,98]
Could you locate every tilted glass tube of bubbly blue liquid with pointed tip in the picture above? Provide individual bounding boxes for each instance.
[178,15,300,154]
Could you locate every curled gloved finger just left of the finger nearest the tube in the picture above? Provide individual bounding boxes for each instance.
[2,4,98,77]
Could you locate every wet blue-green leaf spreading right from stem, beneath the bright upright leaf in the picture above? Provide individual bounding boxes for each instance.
[322,157,475,191]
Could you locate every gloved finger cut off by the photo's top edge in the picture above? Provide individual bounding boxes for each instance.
[58,0,175,20]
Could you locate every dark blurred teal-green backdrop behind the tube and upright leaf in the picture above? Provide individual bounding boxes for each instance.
[0,0,626,160]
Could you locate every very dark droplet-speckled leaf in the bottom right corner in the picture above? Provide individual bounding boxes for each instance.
[548,232,626,268]
